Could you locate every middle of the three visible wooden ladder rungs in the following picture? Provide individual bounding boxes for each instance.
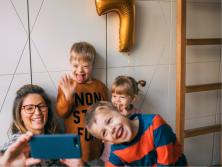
[186,83,222,93]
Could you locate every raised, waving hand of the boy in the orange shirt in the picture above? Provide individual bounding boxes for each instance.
[59,74,76,101]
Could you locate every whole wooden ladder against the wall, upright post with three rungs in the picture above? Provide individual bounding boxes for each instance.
[176,0,222,149]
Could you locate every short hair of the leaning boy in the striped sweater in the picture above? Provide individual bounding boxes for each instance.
[85,101,116,127]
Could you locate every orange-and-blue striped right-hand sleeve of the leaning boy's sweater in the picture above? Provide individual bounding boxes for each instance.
[152,115,182,166]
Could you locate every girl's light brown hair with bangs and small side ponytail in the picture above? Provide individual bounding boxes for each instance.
[111,76,146,97]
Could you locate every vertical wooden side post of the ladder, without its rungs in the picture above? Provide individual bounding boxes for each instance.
[176,0,186,146]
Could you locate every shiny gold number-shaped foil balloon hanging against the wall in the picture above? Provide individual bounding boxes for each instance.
[95,0,135,52]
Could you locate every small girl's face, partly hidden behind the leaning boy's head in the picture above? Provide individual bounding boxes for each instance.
[111,93,134,116]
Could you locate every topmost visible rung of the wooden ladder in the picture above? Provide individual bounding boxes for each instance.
[186,38,222,45]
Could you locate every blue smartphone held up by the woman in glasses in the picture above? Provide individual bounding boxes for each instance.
[29,134,81,159]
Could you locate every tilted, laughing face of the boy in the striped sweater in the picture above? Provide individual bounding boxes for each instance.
[88,109,132,144]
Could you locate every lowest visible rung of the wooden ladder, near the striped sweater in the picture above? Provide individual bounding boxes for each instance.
[184,124,221,138]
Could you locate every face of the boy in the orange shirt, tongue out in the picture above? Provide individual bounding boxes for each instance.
[71,55,93,83]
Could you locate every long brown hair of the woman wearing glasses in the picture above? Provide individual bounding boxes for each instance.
[11,84,56,134]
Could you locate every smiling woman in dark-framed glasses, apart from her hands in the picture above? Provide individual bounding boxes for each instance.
[0,84,62,166]
